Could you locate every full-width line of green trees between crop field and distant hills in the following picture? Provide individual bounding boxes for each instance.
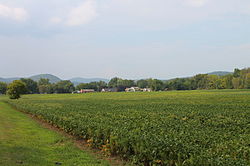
[0,68,250,98]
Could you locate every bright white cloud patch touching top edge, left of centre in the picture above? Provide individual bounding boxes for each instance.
[66,0,97,26]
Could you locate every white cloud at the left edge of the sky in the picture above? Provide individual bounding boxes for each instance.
[0,4,28,21]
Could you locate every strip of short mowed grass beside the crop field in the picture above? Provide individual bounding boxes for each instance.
[0,101,108,166]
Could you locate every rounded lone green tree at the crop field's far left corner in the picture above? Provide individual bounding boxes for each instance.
[7,80,27,99]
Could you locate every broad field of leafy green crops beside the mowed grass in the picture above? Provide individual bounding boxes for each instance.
[6,90,250,166]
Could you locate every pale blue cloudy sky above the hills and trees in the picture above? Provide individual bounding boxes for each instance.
[0,0,250,79]
